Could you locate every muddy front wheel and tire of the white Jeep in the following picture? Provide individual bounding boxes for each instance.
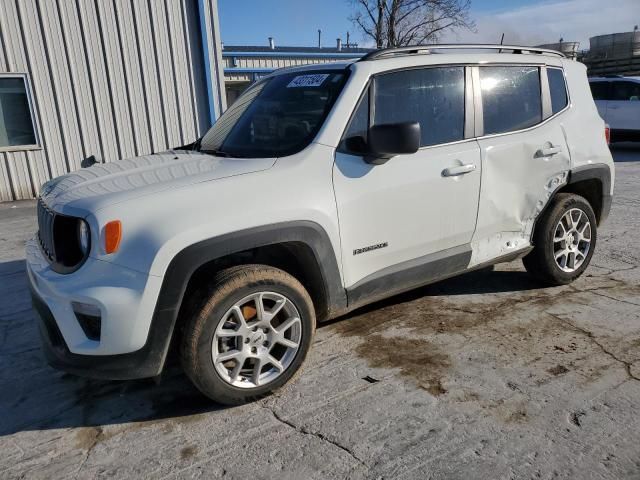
[180,265,315,405]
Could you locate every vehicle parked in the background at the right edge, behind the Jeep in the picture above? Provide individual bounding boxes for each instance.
[589,76,640,142]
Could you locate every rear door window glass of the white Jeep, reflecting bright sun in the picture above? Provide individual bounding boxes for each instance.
[480,66,542,135]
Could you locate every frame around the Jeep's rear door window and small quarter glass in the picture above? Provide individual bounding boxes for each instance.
[471,62,573,139]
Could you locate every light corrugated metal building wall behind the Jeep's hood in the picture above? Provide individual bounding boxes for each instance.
[0,0,221,201]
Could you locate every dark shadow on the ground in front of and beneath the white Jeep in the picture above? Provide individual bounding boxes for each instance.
[0,261,539,436]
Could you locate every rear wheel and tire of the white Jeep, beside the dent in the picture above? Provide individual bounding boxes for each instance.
[522,193,597,286]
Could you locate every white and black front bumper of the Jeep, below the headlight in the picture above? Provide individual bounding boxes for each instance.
[26,235,174,380]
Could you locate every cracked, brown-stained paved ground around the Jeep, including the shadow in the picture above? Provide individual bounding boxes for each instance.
[0,145,640,479]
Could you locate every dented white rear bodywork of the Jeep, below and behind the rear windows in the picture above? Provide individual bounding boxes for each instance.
[469,60,613,268]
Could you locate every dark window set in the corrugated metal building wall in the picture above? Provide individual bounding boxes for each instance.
[0,76,37,150]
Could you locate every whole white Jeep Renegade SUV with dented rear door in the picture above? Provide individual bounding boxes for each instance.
[26,45,614,404]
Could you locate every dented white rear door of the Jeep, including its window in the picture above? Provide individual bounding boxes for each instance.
[471,65,570,266]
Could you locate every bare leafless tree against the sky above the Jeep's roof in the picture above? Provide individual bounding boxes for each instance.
[349,0,475,48]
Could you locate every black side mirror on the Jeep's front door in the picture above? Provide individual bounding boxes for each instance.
[365,122,420,165]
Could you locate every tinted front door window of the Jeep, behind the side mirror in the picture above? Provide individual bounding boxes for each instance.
[373,67,464,146]
